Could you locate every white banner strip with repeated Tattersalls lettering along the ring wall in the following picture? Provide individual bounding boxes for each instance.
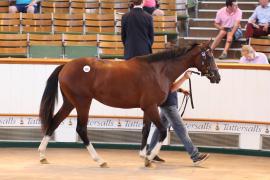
[0,116,269,135]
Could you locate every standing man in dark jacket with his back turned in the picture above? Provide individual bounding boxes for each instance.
[121,0,154,60]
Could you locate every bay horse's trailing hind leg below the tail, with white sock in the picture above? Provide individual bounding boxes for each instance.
[38,98,74,164]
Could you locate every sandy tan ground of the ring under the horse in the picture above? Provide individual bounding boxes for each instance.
[0,148,270,180]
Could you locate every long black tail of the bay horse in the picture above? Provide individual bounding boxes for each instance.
[39,65,64,132]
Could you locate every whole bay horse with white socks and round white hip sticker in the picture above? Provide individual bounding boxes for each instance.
[38,41,220,167]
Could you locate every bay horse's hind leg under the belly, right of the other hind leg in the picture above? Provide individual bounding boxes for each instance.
[76,100,107,167]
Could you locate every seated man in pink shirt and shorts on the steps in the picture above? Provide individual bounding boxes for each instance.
[211,0,243,59]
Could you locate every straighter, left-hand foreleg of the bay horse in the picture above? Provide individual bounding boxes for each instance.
[139,114,151,158]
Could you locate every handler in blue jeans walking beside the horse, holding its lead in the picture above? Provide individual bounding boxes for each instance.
[149,71,209,165]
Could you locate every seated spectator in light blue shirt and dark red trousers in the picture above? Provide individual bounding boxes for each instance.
[246,0,270,44]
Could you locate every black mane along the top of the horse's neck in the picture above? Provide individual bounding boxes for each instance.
[140,43,199,62]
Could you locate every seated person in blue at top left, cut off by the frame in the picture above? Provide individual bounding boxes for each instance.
[9,0,37,13]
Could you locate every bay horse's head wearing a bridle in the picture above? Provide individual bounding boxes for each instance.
[195,41,220,83]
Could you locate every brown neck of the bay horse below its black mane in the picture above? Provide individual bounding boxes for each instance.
[166,55,194,82]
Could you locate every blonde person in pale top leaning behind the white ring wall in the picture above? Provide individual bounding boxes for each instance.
[240,45,269,64]
